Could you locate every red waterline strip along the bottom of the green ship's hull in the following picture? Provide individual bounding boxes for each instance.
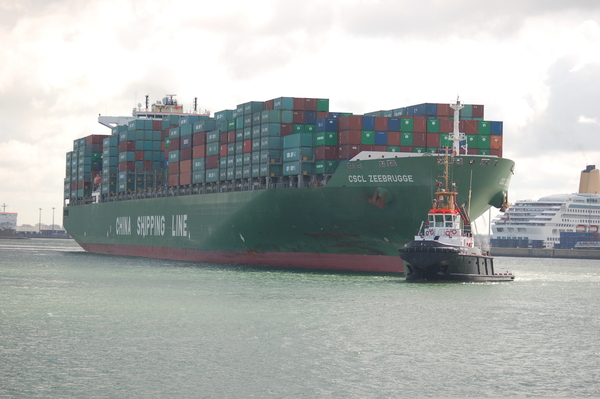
[80,243,404,274]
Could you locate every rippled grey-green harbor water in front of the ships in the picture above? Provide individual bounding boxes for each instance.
[0,239,600,398]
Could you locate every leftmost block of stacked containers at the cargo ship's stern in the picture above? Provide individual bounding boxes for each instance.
[64,135,109,199]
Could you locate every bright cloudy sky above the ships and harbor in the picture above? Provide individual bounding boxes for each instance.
[0,0,600,225]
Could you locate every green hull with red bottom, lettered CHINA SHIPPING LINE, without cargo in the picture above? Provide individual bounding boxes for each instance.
[64,155,514,273]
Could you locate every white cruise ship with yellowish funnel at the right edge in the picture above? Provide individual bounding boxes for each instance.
[491,165,600,248]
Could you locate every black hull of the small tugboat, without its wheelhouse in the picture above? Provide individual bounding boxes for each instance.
[400,240,514,282]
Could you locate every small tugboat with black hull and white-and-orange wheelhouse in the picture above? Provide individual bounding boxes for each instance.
[400,101,515,282]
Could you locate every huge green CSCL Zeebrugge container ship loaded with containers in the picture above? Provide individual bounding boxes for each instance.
[63,96,514,274]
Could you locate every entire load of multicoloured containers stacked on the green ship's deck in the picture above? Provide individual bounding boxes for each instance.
[65,97,503,198]
